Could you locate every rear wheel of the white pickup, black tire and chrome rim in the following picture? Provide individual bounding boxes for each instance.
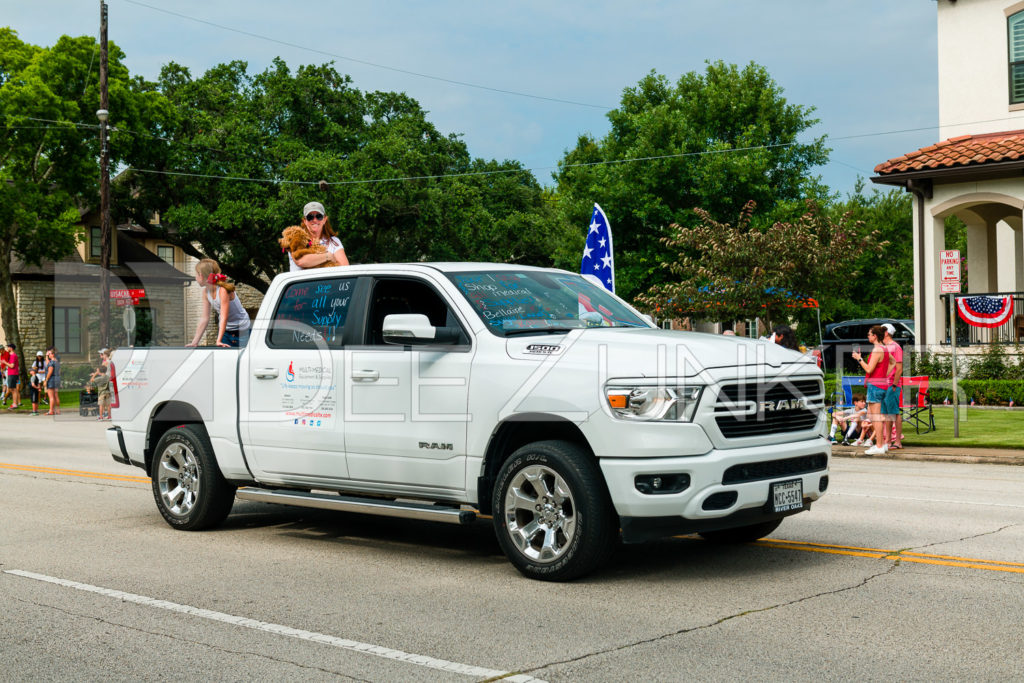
[152,425,234,531]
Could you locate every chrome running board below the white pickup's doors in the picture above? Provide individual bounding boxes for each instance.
[234,486,476,524]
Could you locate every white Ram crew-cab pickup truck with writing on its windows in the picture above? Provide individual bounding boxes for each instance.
[108,263,830,580]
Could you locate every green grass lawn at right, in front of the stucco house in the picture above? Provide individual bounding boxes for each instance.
[903,405,1024,449]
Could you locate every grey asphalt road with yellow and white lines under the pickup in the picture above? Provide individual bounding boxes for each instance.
[0,415,1024,681]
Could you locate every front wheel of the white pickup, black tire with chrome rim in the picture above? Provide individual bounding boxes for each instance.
[492,441,618,581]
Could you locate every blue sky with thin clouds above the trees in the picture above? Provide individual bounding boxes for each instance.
[0,0,938,195]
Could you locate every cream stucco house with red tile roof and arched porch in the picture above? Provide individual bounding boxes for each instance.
[871,0,1024,348]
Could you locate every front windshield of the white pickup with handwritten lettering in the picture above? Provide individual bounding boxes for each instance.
[449,270,648,337]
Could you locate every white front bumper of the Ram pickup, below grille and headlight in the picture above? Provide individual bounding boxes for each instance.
[600,437,831,541]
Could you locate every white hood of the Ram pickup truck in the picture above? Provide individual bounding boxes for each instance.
[506,328,817,378]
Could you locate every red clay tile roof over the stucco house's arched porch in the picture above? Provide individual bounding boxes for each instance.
[874,130,1024,175]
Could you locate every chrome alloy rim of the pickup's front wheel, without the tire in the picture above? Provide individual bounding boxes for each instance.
[505,465,577,562]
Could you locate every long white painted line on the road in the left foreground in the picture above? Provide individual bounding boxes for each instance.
[4,569,544,683]
